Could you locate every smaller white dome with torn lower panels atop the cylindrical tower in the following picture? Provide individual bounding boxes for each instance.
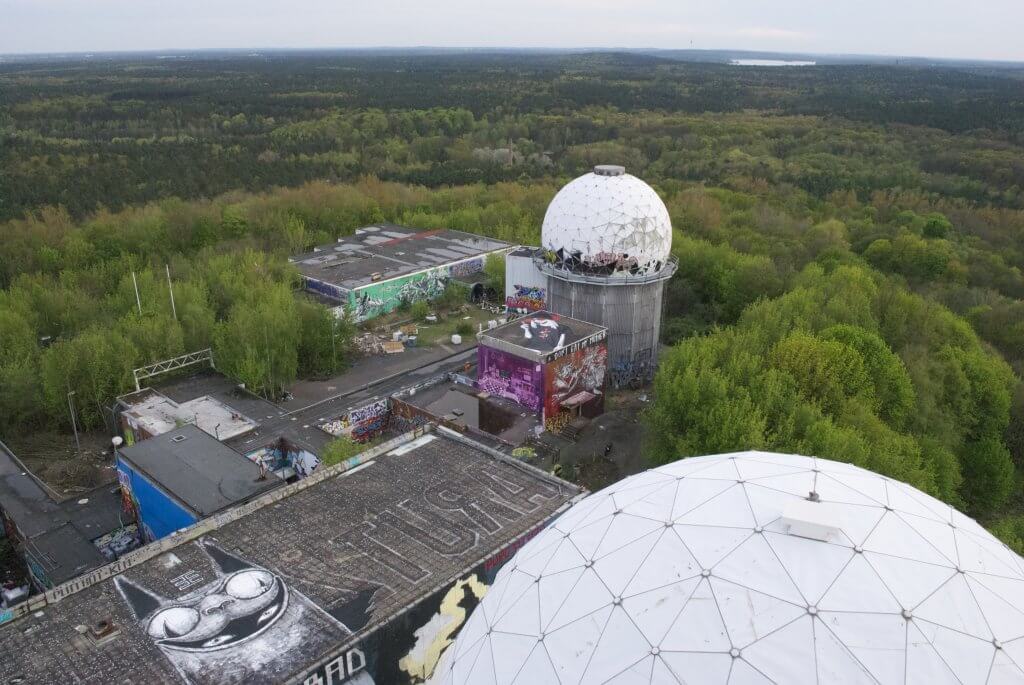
[541,166,672,274]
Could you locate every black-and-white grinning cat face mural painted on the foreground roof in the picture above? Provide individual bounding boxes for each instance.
[115,539,373,683]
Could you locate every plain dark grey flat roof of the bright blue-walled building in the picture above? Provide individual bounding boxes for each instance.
[118,425,281,516]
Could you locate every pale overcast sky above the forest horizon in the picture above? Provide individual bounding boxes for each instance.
[0,0,1024,60]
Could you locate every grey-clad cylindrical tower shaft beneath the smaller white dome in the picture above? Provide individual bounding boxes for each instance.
[548,279,665,388]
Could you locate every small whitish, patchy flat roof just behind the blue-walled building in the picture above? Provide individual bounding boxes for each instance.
[121,388,257,440]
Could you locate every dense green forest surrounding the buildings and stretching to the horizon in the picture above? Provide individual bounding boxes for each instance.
[6,54,1024,549]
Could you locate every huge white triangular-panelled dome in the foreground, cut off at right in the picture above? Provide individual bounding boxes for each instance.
[436,452,1024,685]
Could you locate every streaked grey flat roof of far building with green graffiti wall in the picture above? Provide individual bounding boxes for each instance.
[291,223,512,290]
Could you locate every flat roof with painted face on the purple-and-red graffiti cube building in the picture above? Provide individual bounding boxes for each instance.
[476,310,608,360]
